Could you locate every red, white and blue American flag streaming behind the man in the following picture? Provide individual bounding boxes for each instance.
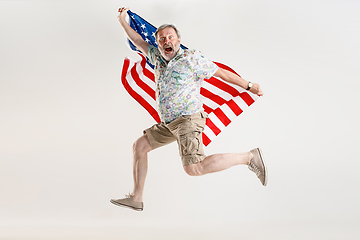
[121,11,259,146]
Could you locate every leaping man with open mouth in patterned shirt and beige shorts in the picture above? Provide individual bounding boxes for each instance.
[111,8,267,211]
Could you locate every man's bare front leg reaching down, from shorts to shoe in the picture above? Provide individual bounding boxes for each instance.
[131,134,152,202]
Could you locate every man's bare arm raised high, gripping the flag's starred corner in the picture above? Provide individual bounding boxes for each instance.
[118,8,149,56]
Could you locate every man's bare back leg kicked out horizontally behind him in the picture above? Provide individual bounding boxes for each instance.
[184,152,253,176]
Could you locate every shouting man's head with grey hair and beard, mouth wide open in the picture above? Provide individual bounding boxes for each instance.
[157,27,181,61]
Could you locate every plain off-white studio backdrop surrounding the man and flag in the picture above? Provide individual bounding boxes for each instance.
[0,0,360,240]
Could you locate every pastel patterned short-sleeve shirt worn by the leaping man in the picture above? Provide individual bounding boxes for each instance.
[148,45,218,123]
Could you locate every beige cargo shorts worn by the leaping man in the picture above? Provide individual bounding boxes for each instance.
[144,111,207,166]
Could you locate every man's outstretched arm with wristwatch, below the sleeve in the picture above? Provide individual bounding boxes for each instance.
[214,68,264,96]
